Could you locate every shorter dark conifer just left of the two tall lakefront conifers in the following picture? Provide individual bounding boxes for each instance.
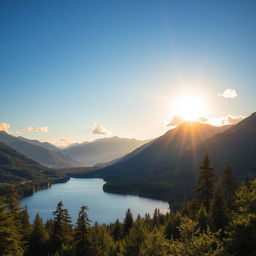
[26,213,49,256]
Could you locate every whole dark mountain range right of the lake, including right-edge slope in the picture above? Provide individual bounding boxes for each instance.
[85,113,256,205]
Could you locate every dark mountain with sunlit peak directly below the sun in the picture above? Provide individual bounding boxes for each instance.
[86,122,236,205]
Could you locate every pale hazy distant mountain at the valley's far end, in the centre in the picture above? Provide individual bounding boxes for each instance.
[62,137,152,165]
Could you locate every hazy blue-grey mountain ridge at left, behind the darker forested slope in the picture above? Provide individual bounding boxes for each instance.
[0,132,82,168]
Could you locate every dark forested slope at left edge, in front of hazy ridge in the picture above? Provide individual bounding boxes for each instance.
[0,142,61,184]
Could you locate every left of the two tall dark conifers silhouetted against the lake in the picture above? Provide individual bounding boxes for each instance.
[50,201,73,253]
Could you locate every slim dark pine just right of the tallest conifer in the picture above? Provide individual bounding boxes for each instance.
[222,165,236,211]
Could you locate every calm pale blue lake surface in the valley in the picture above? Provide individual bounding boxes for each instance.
[21,178,169,223]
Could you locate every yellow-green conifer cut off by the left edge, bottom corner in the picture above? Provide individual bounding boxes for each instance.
[0,198,23,256]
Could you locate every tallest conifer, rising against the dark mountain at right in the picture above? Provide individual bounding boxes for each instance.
[196,154,214,212]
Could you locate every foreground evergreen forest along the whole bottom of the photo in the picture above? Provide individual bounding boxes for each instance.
[0,155,256,256]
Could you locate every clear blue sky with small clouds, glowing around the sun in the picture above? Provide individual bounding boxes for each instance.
[0,0,256,145]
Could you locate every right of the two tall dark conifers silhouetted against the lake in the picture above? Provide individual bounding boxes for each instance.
[74,206,90,256]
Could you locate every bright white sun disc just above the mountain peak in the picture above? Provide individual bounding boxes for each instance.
[175,93,205,121]
